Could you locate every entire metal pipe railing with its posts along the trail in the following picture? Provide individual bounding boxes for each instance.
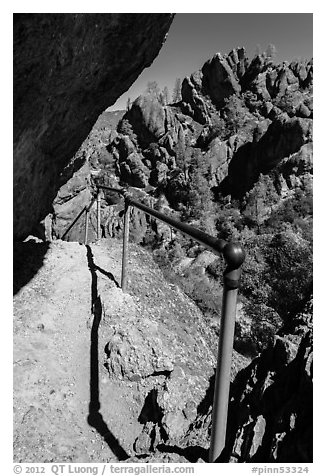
[61,185,245,463]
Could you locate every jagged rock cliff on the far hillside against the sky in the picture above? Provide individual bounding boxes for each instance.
[49,48,313,244]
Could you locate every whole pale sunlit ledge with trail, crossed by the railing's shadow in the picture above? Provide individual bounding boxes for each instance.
[14,239,248,462]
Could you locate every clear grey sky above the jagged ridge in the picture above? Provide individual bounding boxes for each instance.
[108,13,313,110]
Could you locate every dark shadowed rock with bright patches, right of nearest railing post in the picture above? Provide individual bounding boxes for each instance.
[223,301,313,463]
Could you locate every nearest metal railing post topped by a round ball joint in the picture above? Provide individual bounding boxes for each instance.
[209,243,244,463]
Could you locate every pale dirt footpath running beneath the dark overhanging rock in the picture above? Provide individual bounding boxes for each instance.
[14,241,141,462]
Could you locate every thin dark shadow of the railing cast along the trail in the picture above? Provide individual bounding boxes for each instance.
[86,245,129,461]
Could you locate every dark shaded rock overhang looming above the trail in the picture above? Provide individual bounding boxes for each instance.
[14,13,173,239]
